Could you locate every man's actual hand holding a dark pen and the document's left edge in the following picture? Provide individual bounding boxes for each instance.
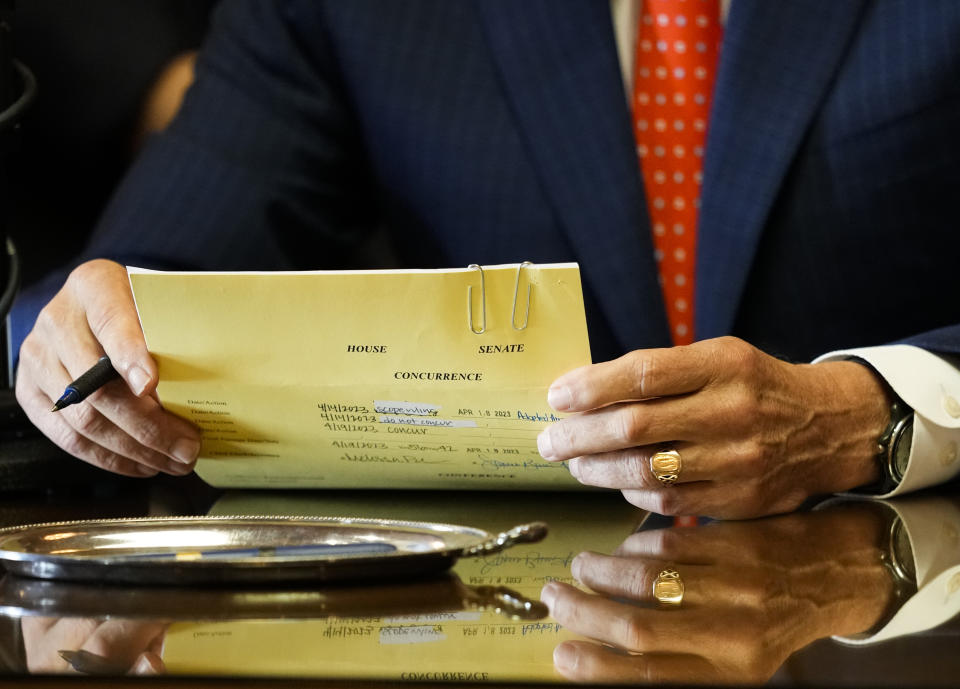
[16,260,200,476]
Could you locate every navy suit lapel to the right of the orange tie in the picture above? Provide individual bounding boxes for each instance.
[695,0,864,339]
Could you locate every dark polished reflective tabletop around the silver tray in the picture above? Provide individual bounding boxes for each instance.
[0,438,960,687]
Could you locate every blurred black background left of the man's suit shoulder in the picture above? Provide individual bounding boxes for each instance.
[4,0,216,285]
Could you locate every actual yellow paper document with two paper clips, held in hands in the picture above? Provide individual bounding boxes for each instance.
[129,264,590,488]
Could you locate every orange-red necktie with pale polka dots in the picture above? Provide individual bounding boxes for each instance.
[633,0,723,344]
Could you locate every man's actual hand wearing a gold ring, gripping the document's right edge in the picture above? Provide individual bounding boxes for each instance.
[537,337,890,518]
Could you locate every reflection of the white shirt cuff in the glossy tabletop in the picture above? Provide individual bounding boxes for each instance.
[833,497,960,646]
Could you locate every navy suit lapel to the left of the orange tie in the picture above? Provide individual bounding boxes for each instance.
[476,0,669,349]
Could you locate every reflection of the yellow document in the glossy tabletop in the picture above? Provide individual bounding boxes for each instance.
[163,491,644,682]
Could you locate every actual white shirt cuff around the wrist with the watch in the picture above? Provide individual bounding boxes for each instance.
[814,345,960,497]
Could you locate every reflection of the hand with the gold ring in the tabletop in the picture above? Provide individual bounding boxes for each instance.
[541,503,893,683]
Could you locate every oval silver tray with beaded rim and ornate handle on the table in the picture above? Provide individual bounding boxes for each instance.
[0,517,546,586]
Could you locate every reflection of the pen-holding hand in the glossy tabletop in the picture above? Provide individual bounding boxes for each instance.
[21,617,167,675]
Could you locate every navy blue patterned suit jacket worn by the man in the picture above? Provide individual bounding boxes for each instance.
[11,0,960,360]
